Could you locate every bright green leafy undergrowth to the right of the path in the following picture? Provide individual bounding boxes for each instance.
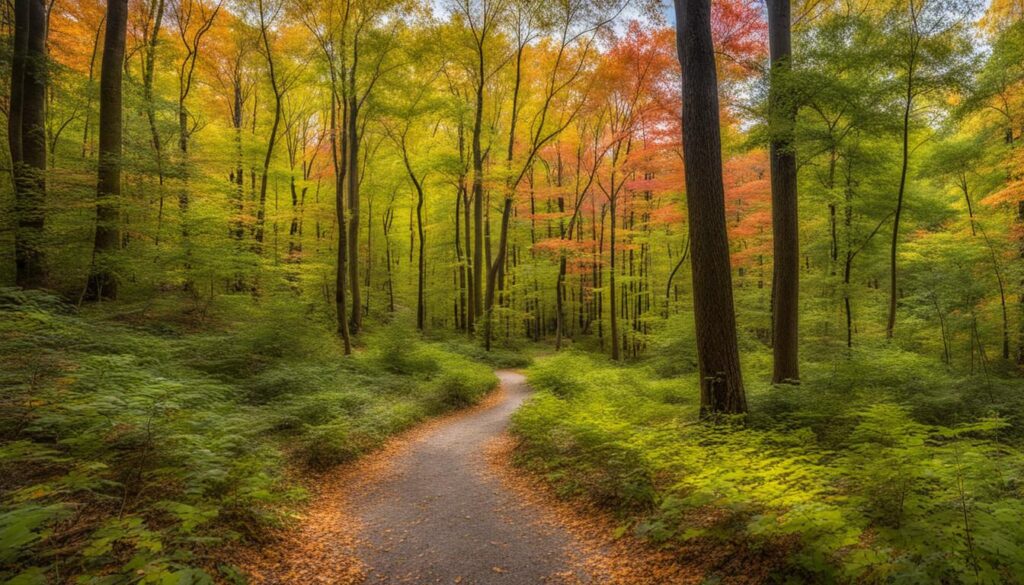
[513,347,1024,583]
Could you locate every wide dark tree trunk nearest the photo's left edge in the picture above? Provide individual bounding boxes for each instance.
[11,0,46,288]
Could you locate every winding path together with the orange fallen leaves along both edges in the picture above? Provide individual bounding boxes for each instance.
[241,371,700,585]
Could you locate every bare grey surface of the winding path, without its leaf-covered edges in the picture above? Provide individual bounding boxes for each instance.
[351,371,588,585]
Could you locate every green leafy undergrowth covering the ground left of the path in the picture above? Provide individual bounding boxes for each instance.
[0,289,497,584]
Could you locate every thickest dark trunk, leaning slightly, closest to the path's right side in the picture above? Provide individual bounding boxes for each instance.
[675,0,746,415]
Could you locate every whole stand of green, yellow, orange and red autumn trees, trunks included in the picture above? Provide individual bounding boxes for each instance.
[5,0,1024,387]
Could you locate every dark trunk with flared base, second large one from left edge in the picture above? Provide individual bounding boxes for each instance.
[86,0,128,300]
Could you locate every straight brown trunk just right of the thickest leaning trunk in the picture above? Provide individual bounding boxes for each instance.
[768,0,800,384]
